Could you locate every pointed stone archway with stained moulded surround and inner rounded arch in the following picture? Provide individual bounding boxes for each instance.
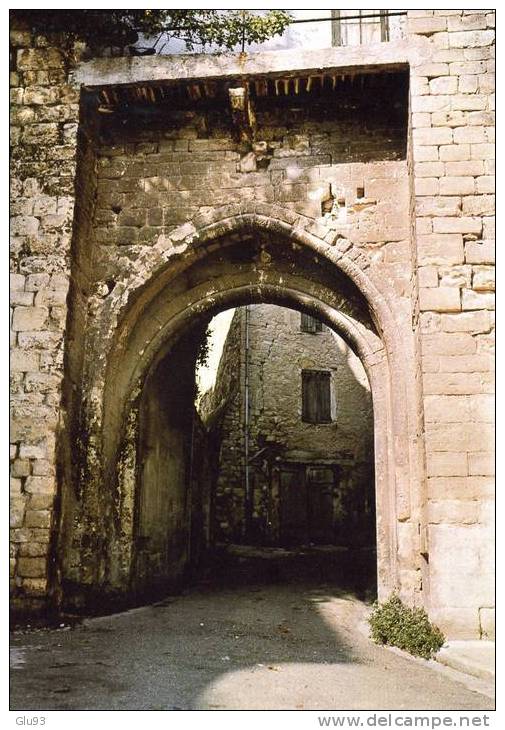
[56,205,422,612]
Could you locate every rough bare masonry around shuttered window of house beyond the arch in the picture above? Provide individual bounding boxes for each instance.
[206,304,374,542]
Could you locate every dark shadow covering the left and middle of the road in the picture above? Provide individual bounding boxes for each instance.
[11,549,372,710]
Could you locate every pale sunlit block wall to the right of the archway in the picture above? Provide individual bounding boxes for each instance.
[408,10,495,636]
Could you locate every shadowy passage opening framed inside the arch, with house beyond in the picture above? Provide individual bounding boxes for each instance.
[133,304,376,595]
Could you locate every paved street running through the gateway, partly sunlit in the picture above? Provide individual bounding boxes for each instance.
[11,582,494,710]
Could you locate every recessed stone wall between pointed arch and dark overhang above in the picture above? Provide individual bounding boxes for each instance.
[88,74,408,258]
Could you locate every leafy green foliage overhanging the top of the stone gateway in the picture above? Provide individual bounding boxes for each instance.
[11,9,291,50]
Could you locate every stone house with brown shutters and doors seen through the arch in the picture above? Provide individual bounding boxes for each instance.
[202,304,375,547]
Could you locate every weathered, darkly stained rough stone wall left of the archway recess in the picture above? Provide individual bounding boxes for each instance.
[10,30,79,605]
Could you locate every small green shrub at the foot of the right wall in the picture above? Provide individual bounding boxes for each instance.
[368,593,445,659]
